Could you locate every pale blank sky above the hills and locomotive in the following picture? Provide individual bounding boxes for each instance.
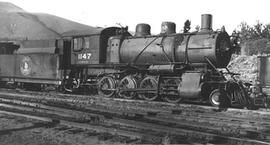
[5,0,270,33]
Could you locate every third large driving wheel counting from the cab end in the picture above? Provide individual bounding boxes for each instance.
[139,77,158,101]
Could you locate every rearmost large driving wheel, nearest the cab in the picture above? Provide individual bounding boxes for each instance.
[98,76,116,97]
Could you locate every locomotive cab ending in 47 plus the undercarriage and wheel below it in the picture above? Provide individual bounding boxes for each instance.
[58,27,129,92]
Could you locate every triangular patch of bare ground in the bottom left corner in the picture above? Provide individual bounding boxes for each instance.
[0,114,137,145]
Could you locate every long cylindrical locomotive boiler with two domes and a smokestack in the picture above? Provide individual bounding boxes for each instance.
[118,15,233,68]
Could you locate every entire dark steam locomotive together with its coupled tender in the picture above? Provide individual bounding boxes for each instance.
[0,14,264,106]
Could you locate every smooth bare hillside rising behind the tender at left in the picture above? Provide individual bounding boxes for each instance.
[0,2,97,41]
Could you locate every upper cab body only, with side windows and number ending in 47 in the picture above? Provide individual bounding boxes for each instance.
[60,27,124,66]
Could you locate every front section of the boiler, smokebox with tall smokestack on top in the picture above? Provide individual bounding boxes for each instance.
[175,14,233,68]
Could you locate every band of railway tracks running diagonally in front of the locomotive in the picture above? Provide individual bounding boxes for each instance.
[0,89,270,144]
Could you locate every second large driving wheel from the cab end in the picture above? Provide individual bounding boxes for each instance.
[118,76,138,99]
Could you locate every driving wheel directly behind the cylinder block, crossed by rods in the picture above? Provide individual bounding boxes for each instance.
[161,79,183,103]
